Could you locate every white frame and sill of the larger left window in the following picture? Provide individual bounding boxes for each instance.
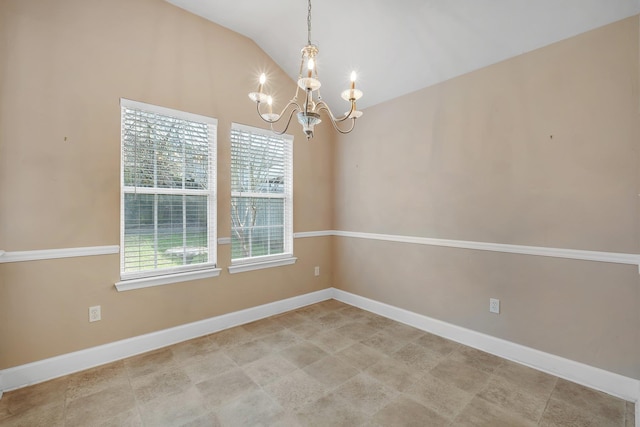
[115,98,221,291]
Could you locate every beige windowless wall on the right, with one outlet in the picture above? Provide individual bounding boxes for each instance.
[334,17,640,378]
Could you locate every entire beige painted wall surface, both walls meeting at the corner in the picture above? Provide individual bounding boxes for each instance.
[0,0,640,384]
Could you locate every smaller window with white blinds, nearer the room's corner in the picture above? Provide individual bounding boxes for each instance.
[229,123,295,273]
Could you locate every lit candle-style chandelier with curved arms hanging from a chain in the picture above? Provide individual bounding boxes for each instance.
[249,0,362,139]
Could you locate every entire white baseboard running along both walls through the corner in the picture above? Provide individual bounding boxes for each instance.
[0,288,640,416]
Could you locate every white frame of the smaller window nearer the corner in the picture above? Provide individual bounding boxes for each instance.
[228,123,297,274]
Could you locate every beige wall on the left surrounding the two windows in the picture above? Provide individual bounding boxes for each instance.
[0,0,333,369]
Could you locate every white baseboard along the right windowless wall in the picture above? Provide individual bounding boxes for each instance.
[333,289,640,404]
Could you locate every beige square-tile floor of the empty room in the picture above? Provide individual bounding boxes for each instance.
[0,300,634,427]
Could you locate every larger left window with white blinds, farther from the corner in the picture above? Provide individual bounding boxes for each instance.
[116,99,219,289]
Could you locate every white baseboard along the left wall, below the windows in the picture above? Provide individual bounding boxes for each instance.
[0,288,333,397]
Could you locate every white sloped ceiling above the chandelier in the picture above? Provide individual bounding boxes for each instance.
[167,0,640,110]
